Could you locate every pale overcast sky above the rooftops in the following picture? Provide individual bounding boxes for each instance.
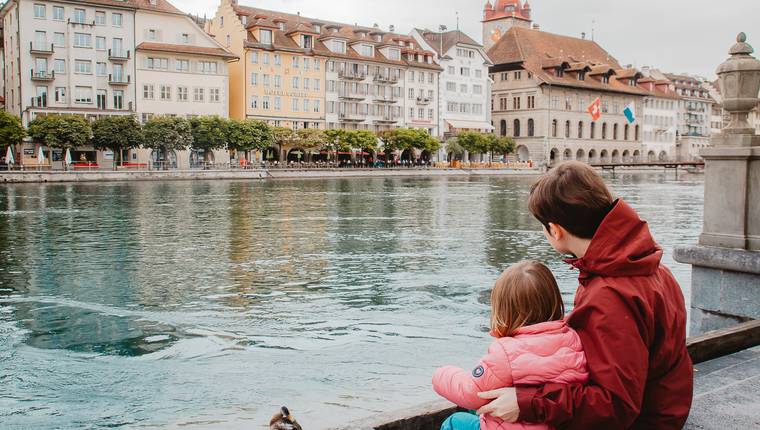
[181,0,760,78]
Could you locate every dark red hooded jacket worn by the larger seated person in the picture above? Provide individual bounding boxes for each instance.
[517,200,694,430]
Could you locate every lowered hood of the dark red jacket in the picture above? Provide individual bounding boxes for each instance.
[566,200,662,280]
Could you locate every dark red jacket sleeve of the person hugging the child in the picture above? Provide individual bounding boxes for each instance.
[517,287,649,429]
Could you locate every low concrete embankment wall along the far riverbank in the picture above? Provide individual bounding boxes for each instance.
[0,169,540,183]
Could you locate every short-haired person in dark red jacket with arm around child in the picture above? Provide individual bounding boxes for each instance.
[480,162,693,430]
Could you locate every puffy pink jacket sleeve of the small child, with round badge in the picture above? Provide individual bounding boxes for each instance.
[433,344,511,410]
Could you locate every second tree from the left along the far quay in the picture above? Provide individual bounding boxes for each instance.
[28,115,92,168]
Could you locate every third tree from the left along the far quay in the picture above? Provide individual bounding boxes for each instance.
[92,115,143,169]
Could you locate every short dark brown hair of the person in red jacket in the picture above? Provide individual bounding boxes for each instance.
[528,161,615,239]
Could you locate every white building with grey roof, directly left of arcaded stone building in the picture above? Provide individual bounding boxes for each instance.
[412,29,494,146]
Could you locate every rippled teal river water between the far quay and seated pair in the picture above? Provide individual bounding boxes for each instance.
[0,173,703,430]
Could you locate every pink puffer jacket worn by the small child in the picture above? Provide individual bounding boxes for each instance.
[433,321,588,430]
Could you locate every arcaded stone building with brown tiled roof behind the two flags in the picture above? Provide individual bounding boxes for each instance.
[488,23,648,164]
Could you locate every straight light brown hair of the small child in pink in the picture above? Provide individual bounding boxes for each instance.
[491,261,565,338]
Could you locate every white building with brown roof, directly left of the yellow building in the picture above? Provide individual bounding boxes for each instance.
[129,0,238,169]
